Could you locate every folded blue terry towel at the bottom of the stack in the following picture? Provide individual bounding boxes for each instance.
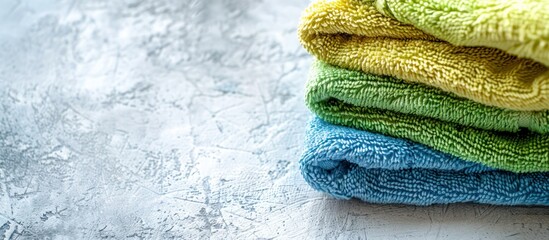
[300,119,549,205]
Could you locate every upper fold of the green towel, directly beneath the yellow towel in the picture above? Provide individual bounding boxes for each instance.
[307,61,549,134]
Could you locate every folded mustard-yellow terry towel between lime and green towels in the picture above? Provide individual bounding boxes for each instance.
[299,0,549,110]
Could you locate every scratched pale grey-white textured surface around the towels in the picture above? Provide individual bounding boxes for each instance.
[0,0,549,239]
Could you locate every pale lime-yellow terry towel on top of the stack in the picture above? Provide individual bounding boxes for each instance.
[374,0,549,66]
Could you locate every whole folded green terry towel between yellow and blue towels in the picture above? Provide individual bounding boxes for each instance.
[306,62,549,172]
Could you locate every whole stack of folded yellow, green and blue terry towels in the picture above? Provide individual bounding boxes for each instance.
[299,0,549,205]
